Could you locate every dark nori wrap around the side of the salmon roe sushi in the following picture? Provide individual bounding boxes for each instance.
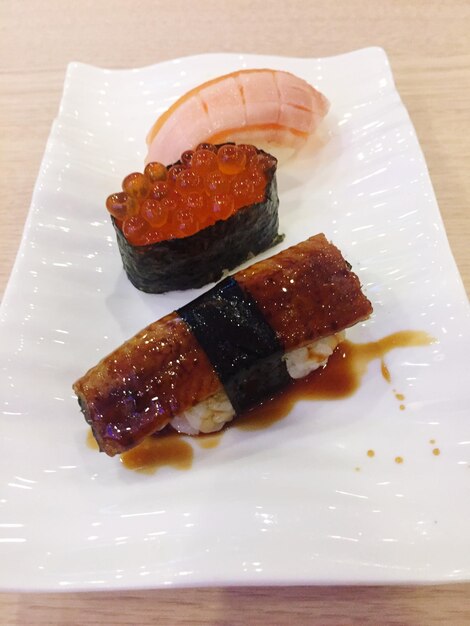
[111,150,283,293]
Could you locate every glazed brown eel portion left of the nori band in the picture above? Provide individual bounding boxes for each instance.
[74,313,220,455]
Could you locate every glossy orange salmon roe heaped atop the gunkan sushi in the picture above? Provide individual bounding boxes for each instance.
[106,143,276,246]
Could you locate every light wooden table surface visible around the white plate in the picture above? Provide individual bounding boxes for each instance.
[0,0,470,626]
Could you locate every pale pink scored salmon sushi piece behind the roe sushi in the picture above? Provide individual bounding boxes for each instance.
[146,69,329,164]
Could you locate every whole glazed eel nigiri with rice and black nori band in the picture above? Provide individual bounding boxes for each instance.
[73,234,372,456]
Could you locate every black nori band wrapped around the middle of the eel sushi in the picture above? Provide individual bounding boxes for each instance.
[177,276,290,414]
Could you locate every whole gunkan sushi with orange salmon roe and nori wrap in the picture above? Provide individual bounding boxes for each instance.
[106,143,282,293]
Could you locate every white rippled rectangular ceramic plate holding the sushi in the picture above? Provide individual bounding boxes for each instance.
[0,48,470,590]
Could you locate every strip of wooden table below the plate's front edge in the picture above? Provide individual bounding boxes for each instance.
[0,585,470,626]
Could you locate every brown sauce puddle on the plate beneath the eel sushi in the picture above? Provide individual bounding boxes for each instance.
[94,331,436,473]
